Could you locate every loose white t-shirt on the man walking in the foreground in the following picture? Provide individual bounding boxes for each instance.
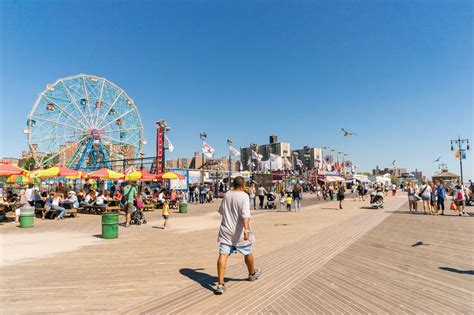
[217,190,255,246]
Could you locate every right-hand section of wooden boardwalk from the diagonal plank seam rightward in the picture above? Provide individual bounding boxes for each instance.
[124,205,474,314]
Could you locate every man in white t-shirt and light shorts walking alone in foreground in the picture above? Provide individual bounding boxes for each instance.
[215,176,262,294]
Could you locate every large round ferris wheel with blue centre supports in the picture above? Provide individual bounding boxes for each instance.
[23,74,145,170]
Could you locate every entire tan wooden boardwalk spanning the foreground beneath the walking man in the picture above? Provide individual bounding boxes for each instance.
[0,198,474,314]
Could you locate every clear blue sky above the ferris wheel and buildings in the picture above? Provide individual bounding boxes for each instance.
[0,0,474,178]
